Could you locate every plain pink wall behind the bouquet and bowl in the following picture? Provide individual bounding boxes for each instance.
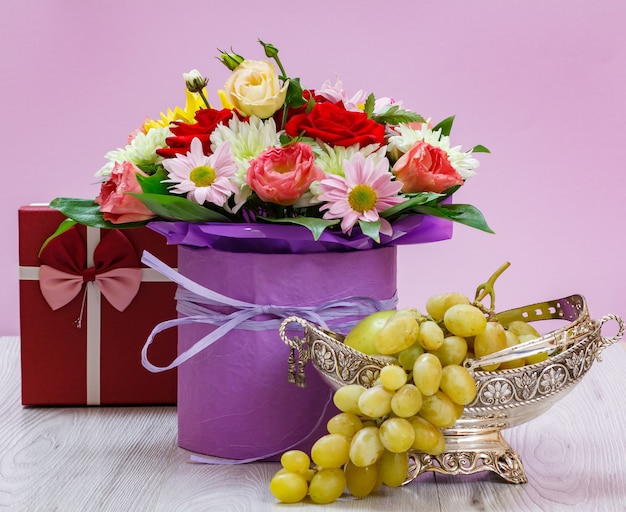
[0,0,626,335]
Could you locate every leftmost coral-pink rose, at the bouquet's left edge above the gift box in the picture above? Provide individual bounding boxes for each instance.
[96,162,155,224]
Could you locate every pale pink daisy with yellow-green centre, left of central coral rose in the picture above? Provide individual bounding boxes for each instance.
[163,138,238,206]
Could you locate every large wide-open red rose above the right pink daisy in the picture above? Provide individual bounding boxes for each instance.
[285,102,385,147]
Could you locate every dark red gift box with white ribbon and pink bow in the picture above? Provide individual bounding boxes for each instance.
[18,206,177,405]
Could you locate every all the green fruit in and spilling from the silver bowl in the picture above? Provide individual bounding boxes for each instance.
[270,266,541,503]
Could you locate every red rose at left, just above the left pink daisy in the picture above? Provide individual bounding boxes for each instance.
[157,108,233,158]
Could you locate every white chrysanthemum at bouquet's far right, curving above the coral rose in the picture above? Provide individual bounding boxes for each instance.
[388,123,480,180]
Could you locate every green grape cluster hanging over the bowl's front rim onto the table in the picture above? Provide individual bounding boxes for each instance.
[270,309,476,503]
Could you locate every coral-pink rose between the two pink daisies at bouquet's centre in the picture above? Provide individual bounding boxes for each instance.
[246,142,325,206]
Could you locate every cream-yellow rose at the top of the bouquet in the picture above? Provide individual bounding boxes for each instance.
[224,60,289,119]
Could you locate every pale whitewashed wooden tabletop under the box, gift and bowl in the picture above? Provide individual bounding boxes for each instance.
[0,337,626,512]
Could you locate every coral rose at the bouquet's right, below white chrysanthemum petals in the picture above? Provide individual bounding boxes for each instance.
[391,141,463,193]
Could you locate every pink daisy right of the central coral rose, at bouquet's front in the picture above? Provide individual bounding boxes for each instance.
[318,153,405,235]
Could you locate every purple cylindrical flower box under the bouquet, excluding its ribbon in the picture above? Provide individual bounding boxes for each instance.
[171,245,397,459]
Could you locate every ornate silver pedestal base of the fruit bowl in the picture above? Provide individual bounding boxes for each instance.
[405,431,528,484]
